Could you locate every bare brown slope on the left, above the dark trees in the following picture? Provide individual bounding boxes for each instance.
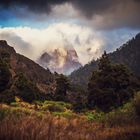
[0,40,54,94]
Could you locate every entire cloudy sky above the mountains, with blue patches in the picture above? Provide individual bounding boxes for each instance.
[0,0,140,65]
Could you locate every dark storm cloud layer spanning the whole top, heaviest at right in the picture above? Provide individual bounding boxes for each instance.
[0,0,140,29]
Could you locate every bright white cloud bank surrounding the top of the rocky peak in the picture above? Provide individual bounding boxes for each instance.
[0,23,104,64]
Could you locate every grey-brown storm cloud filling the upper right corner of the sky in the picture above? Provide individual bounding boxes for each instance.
[72,0,140,29]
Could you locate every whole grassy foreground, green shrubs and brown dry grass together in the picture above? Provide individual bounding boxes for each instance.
[0,98,140,140]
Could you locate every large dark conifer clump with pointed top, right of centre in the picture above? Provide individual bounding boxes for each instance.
[88,52,139,111]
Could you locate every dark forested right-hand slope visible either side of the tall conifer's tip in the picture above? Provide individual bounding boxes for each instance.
[69,33,140,87]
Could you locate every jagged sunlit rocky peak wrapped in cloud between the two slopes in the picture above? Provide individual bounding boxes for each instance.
[38,48,82,75]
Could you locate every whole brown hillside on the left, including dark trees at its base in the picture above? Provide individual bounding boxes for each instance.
[0,40,54,101]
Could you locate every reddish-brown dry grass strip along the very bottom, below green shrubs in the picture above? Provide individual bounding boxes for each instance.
[0,115,140,140]
